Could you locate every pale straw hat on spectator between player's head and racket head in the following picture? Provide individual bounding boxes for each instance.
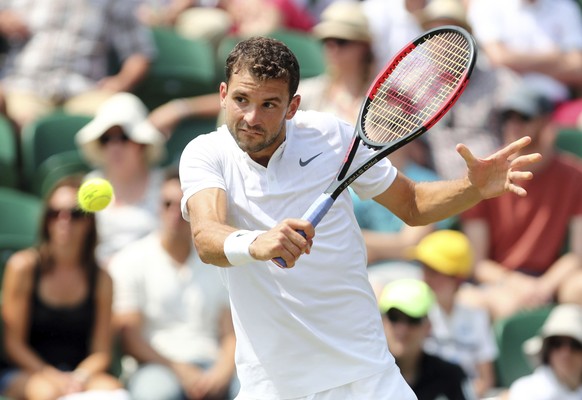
[313,1,372,43]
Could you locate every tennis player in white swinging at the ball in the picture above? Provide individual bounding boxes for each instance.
[180,37,540,400]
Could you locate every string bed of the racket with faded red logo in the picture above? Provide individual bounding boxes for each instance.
[364,32,471,144]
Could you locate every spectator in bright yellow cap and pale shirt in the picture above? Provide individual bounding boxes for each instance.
[412,229,497,396]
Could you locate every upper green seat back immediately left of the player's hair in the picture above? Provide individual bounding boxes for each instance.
[135,27,218,110]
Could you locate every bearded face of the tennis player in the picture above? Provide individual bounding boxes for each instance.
[220,70,300,164]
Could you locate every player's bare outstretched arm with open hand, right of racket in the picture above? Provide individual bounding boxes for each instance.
[374,136,541,226]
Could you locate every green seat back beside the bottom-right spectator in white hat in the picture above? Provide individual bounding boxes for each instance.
[493,307,552,388]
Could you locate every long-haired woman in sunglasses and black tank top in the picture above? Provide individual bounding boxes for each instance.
[0,177,129,400]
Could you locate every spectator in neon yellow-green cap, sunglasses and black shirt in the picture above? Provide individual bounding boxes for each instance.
[378,279,476,400]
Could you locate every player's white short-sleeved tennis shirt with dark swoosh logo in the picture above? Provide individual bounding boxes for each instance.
[180,111,398,399]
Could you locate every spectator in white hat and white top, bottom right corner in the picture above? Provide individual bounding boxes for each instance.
[504,304,582,400]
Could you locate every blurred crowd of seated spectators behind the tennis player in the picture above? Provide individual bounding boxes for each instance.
[0,0,582,400]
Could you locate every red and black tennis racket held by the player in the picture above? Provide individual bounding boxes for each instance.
[273,26,477,268]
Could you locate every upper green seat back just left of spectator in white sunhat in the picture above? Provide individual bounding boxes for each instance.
[21,112,91,194]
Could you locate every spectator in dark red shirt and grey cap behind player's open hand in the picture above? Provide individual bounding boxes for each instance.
[461,86,582,318]
